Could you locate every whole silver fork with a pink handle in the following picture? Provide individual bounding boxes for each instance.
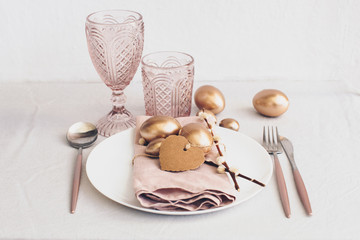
[263,126,291,218]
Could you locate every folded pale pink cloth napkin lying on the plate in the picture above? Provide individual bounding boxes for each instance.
[133,116,236,211]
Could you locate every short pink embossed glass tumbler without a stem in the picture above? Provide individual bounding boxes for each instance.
[141,52,194,117]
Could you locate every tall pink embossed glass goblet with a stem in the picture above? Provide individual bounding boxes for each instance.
[85,10,144,137]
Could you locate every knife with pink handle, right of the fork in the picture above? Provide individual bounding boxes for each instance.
[280,136,312,215]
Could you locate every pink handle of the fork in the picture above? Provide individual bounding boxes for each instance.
[274,153,291,218]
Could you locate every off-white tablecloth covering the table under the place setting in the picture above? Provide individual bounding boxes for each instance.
[0,81,360,239]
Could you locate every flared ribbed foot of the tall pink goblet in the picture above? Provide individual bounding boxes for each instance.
[96,108,136,137]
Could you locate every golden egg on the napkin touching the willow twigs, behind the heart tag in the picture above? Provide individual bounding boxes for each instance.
[179,123,213,153]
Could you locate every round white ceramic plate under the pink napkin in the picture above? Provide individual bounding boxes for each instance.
[86,127,273,215]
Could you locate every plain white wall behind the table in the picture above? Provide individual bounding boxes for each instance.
[0,0,360,84]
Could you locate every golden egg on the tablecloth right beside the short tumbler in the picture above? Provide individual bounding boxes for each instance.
[194,85,225,114]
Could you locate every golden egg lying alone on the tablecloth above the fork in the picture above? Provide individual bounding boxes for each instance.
[253,89,289,117]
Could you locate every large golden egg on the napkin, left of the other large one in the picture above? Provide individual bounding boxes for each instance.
[140,116,181,142]
